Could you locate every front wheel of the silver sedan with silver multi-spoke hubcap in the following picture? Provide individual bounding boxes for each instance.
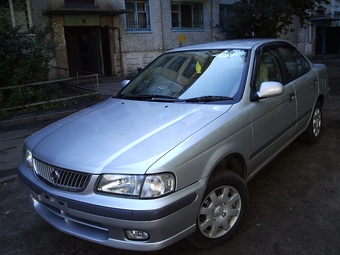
[187,170,249,249]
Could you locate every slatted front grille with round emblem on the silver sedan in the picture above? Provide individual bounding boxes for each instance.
[33,159,91,192]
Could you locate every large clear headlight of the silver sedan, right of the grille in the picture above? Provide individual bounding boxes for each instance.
[96,173,175,198]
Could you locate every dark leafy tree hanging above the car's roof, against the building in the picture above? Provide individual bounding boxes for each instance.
[224,0,329,38]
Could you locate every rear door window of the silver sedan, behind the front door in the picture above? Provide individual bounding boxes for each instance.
[279,47,310,81]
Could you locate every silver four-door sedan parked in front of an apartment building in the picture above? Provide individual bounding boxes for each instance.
[19,39,329,251]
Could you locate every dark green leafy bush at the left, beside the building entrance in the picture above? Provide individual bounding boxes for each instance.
[0,9,58,87]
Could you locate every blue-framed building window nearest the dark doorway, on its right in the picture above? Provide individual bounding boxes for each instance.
[125,0,151,31]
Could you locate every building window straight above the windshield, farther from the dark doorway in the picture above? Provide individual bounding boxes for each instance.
[171,3,204,29]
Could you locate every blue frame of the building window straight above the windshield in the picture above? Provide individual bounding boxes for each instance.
[171,1,204,31]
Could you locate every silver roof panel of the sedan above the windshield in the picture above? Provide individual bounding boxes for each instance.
[168,38,286,52]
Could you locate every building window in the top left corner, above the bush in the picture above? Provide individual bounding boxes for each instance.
[0,0,33,30]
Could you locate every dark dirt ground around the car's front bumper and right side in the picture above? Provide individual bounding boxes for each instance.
[0,60,340,255]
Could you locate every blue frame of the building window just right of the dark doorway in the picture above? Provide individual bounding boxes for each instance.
[125,0,151,32]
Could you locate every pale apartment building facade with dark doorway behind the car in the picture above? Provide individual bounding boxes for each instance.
[1,0,340,78]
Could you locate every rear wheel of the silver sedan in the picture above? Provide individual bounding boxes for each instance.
[300,102,322,144]
